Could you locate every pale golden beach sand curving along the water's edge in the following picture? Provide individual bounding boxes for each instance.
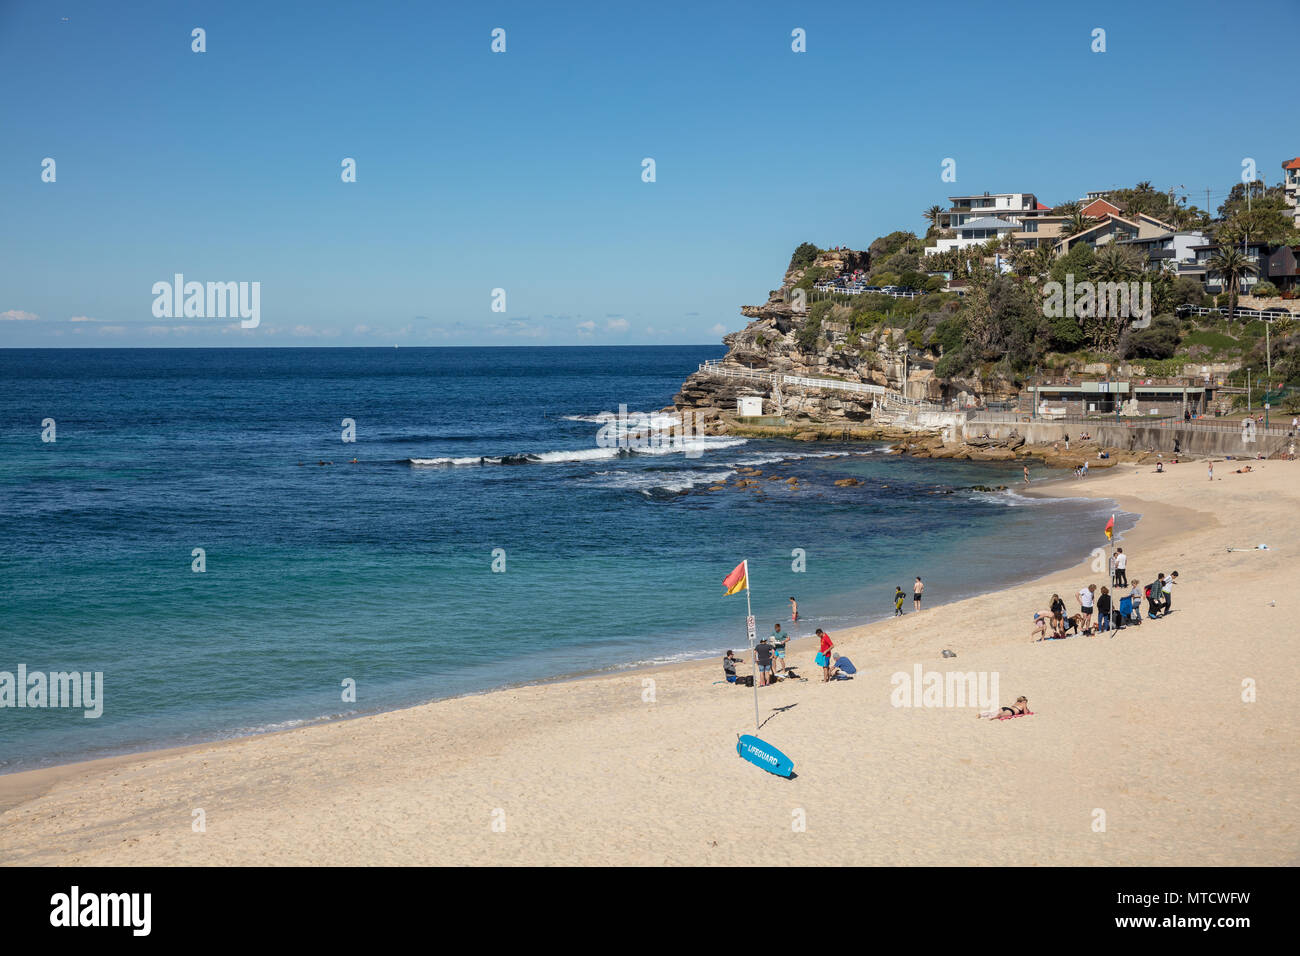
[0,462,1300,866]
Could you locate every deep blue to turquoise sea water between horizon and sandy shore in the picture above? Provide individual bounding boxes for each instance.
[0,346,1128,770]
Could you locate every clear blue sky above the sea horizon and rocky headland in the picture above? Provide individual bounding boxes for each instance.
[0,0,1300,347]
